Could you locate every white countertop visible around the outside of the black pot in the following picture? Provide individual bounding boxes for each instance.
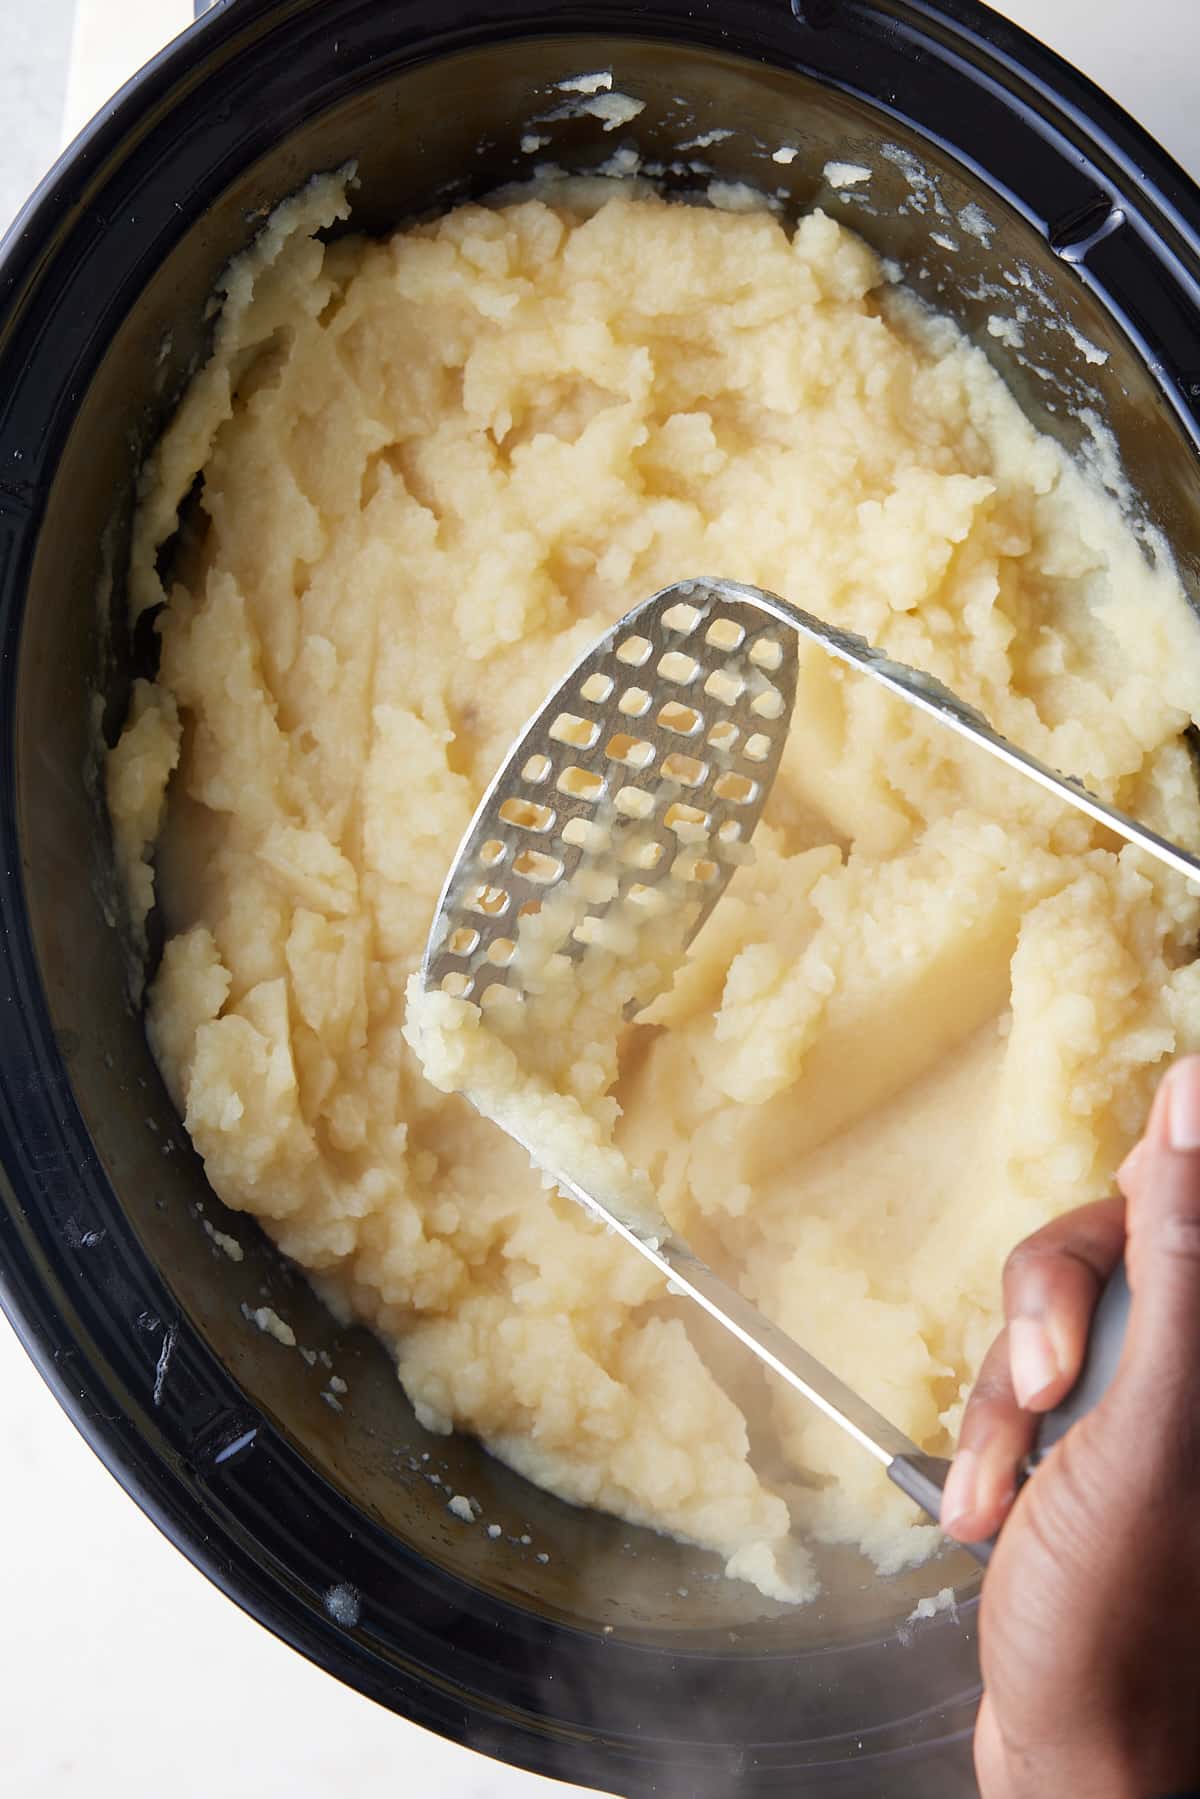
[0,0,1200,1799]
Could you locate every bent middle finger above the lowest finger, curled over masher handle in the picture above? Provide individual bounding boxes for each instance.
[1004,1195,1124,1412]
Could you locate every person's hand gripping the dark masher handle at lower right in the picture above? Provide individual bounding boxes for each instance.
[943,1056,1200,1799]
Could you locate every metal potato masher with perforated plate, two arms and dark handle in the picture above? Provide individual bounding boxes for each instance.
[421,579,1173,1562]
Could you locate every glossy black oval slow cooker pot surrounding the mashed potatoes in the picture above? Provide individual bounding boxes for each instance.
[0,0,1200,1799]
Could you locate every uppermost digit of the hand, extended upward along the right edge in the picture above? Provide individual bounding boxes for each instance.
[1124,1056,1200,1394]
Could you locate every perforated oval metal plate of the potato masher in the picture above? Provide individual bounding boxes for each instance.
[423,581,797,1004]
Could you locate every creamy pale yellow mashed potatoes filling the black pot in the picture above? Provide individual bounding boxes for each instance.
[108,180,1200,1598]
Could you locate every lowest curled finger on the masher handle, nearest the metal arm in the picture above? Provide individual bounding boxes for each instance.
[941,1331,1033,1544]
